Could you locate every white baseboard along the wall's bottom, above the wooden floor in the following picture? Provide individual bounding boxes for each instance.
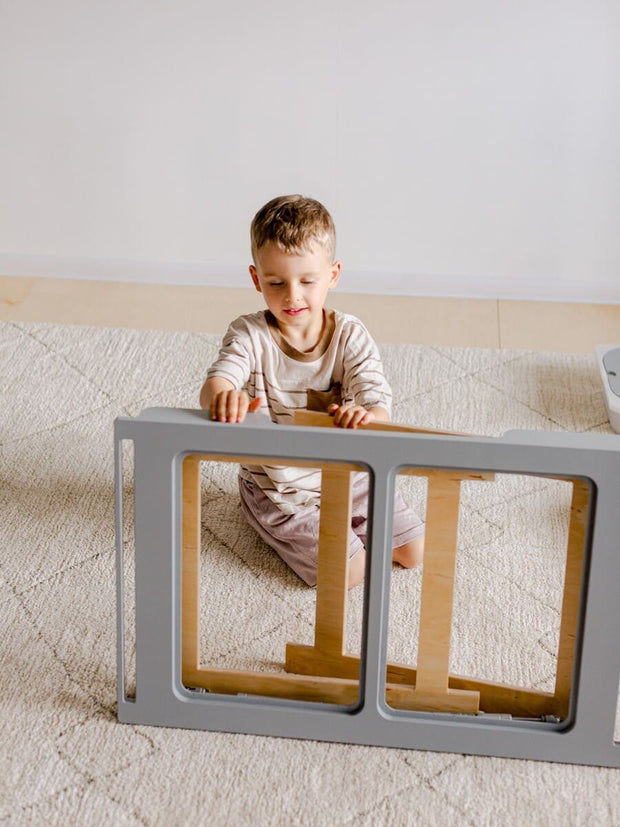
[0,253,620,304]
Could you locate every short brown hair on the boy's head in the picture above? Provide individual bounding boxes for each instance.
[250,195,336,263]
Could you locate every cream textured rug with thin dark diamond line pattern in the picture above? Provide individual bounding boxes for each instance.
[0,323,620,827]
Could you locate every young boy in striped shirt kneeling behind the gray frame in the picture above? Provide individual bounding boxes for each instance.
[200,195,424,588]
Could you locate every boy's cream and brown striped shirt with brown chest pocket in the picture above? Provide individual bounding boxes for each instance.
[207,310,392,514]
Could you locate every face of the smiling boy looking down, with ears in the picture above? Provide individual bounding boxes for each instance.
[250,243,340,333]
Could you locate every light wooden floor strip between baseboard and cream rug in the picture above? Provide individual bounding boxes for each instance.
[0,277,620,353]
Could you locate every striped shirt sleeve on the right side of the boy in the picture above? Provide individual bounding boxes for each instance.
[343,320,392,415]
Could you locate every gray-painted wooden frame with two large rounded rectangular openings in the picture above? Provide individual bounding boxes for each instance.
[115,408,620,767]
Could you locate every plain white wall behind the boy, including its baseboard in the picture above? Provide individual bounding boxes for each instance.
[0,0,620,302]
